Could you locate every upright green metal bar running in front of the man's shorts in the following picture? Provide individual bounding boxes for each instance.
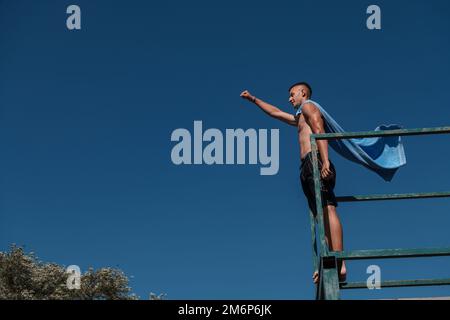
[311,139,328,256]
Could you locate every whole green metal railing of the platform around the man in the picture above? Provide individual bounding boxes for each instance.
[310,127,450,300]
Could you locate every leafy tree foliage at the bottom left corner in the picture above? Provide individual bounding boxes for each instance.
[0,245,138,300]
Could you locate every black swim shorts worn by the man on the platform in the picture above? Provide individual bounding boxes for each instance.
[300,152,337,216]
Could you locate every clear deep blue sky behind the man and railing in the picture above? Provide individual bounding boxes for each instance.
[0,0,450,299]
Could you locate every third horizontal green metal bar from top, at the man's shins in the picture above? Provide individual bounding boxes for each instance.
[329,247,450,260]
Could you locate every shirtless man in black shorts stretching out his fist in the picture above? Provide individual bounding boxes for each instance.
[241,82,346,283]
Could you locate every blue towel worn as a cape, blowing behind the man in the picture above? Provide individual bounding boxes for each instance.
[296,100,406,181]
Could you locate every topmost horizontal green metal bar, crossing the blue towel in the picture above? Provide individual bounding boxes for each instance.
[311,127,450,140]
